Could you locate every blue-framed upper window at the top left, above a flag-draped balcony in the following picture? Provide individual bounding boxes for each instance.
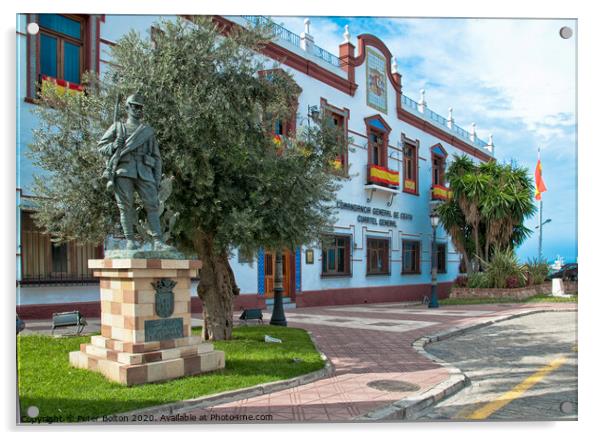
[38,14,84,84]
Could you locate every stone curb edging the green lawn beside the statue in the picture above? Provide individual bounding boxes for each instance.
[96,330,335,422]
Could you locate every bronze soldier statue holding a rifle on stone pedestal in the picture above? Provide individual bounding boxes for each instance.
[98,94,172,250]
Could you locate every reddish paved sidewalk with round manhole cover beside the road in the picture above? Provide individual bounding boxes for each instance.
[179,303,576,422]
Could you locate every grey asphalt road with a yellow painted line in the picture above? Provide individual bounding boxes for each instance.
[417,312,577,421]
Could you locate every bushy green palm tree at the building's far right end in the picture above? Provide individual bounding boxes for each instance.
[438,155,536,273]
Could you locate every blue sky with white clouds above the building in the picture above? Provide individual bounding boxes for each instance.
[272,16,577,262]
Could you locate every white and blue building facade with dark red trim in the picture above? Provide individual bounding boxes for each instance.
[16,14,493,316]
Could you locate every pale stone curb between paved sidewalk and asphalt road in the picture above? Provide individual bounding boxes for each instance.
[353,308,577,421]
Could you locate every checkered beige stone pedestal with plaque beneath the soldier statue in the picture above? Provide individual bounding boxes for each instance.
[69,259,225,385]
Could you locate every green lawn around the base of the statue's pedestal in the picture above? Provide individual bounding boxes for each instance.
[17,326,324,422]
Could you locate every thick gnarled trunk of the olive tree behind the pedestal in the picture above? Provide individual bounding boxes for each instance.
[195,235,238,341]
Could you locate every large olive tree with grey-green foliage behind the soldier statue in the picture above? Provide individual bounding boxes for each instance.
[31,17,345,339]
